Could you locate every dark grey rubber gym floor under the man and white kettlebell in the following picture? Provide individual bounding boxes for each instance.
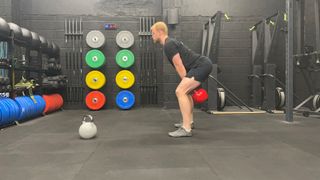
[0,108,320,180]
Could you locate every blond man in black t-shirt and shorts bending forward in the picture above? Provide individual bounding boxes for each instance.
[151,22,212,137]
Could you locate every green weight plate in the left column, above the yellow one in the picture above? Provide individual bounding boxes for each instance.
[86,49,106,69]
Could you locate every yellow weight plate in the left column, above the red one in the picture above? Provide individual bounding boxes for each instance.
[86,71,107,89]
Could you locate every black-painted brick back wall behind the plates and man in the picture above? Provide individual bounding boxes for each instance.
[1,0,285,108]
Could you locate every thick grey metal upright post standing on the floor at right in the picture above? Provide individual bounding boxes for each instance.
[286,0,294,122]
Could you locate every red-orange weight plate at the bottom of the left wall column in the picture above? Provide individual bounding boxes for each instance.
[86,91,106,110]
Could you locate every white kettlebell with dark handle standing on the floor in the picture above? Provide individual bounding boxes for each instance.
[79,115,97,139]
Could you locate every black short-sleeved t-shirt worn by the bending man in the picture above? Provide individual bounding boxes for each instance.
[163,38,200,71]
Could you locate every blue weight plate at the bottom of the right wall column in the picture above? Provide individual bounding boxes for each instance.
[116,90,135,110]
